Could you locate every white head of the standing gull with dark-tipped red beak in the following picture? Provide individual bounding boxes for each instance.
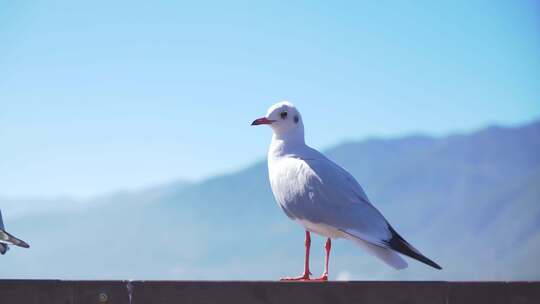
[251,101,304,135]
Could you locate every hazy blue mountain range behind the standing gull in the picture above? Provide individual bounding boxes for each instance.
[0,122,540,280]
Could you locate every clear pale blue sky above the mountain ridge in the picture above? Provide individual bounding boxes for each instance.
[0,1,540,196]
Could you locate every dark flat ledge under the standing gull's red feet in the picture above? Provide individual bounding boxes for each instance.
[0,280,540,304]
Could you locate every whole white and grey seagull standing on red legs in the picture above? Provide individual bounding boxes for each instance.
[251,101,442,281]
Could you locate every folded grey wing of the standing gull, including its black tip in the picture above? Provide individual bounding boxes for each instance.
[286,158,441,269]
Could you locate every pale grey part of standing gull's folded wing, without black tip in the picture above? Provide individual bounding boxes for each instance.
[286,156,392,247]
